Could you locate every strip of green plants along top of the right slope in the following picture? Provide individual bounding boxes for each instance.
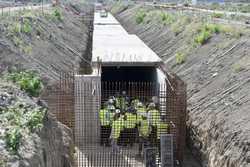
[128,7,249,65]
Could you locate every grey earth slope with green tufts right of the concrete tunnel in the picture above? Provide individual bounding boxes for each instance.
[112,4,250,167]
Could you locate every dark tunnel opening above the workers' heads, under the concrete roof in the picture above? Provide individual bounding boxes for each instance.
[101,66,159,102]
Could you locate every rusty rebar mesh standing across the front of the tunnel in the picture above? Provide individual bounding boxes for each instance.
[44,74,186,167]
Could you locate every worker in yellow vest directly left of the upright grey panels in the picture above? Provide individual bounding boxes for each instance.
[137,112,150,157]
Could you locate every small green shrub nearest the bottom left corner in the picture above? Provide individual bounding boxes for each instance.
[5,127,22,153]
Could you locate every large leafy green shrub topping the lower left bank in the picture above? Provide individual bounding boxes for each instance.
[8,71,43,97]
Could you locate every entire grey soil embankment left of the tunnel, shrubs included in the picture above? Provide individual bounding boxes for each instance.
[0,1,93,167]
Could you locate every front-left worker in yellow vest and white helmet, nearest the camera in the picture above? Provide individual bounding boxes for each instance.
[110,109,124,152]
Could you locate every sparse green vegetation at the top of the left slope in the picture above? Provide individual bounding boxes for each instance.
[1,8,63,55]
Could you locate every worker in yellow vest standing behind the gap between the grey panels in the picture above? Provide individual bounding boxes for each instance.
[147,103,160,144]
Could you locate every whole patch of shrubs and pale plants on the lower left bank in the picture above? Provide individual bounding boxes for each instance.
[0,71,47,166]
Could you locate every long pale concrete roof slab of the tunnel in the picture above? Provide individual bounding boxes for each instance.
[92,13,162,66]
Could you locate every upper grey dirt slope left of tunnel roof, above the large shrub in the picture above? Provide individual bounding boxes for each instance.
[0,3,93,80]
